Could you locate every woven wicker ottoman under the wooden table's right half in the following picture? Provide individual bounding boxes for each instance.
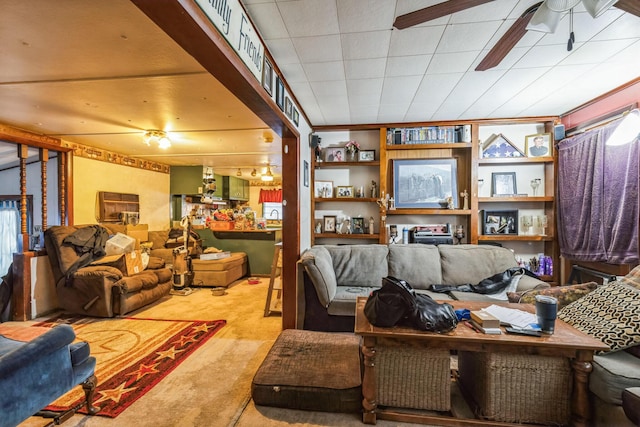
[458,351,573,425]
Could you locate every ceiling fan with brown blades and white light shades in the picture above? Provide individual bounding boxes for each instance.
[393,0,640,71]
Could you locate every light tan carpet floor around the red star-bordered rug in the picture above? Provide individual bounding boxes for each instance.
[20,278,438,427]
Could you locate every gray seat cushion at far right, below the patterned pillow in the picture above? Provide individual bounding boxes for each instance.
[589,351,640,405]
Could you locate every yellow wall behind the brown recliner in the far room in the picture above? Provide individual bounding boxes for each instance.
[73,157,171,230]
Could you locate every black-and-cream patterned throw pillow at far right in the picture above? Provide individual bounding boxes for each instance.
[558,282,640,352]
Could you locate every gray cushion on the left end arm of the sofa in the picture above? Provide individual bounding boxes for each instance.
[300,246,338,308]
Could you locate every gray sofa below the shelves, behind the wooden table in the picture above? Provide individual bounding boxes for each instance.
[297,244,549,332]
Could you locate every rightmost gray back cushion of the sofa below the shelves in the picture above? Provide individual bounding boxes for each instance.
[438,245,518,285]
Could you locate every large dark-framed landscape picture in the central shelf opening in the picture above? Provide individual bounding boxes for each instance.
[393,158,459,209]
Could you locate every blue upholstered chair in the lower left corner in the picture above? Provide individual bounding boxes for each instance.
[0,323,99,427]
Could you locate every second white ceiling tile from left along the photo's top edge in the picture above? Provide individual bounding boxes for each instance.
[278,0,340,37]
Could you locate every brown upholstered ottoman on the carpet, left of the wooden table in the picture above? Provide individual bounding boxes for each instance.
[251,329,362,413]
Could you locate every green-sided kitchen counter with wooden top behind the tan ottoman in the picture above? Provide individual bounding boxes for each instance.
[195,228,282,276]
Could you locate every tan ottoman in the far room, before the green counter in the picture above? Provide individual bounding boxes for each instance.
[191,252,247,287]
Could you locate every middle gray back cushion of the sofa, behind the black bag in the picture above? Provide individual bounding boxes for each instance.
[389,245,442,289]
